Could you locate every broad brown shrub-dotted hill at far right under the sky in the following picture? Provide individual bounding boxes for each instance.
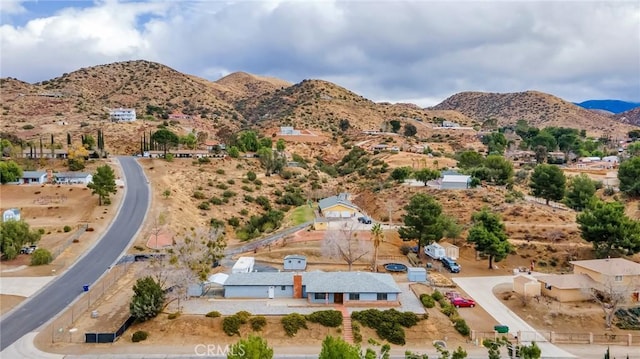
[433,91,631,137]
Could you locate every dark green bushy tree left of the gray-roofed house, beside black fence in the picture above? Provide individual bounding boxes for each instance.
[129,276,165,322]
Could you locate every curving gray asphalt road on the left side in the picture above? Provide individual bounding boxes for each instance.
[0,157,150,350]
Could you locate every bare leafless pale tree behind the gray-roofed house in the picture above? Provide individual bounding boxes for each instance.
[322,223,369,272]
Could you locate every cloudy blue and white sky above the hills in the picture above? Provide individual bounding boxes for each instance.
[0,0,640,106]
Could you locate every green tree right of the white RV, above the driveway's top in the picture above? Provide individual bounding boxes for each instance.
[467,208,511,269]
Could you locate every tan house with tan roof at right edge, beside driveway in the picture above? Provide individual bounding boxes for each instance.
[534,258,640,302]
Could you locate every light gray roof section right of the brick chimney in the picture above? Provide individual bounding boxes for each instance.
[302,272,401,293]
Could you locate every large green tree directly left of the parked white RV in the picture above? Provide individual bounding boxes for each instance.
[398,193,444,248]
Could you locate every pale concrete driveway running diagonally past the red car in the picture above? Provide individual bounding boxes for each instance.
[453,276,576,358]
